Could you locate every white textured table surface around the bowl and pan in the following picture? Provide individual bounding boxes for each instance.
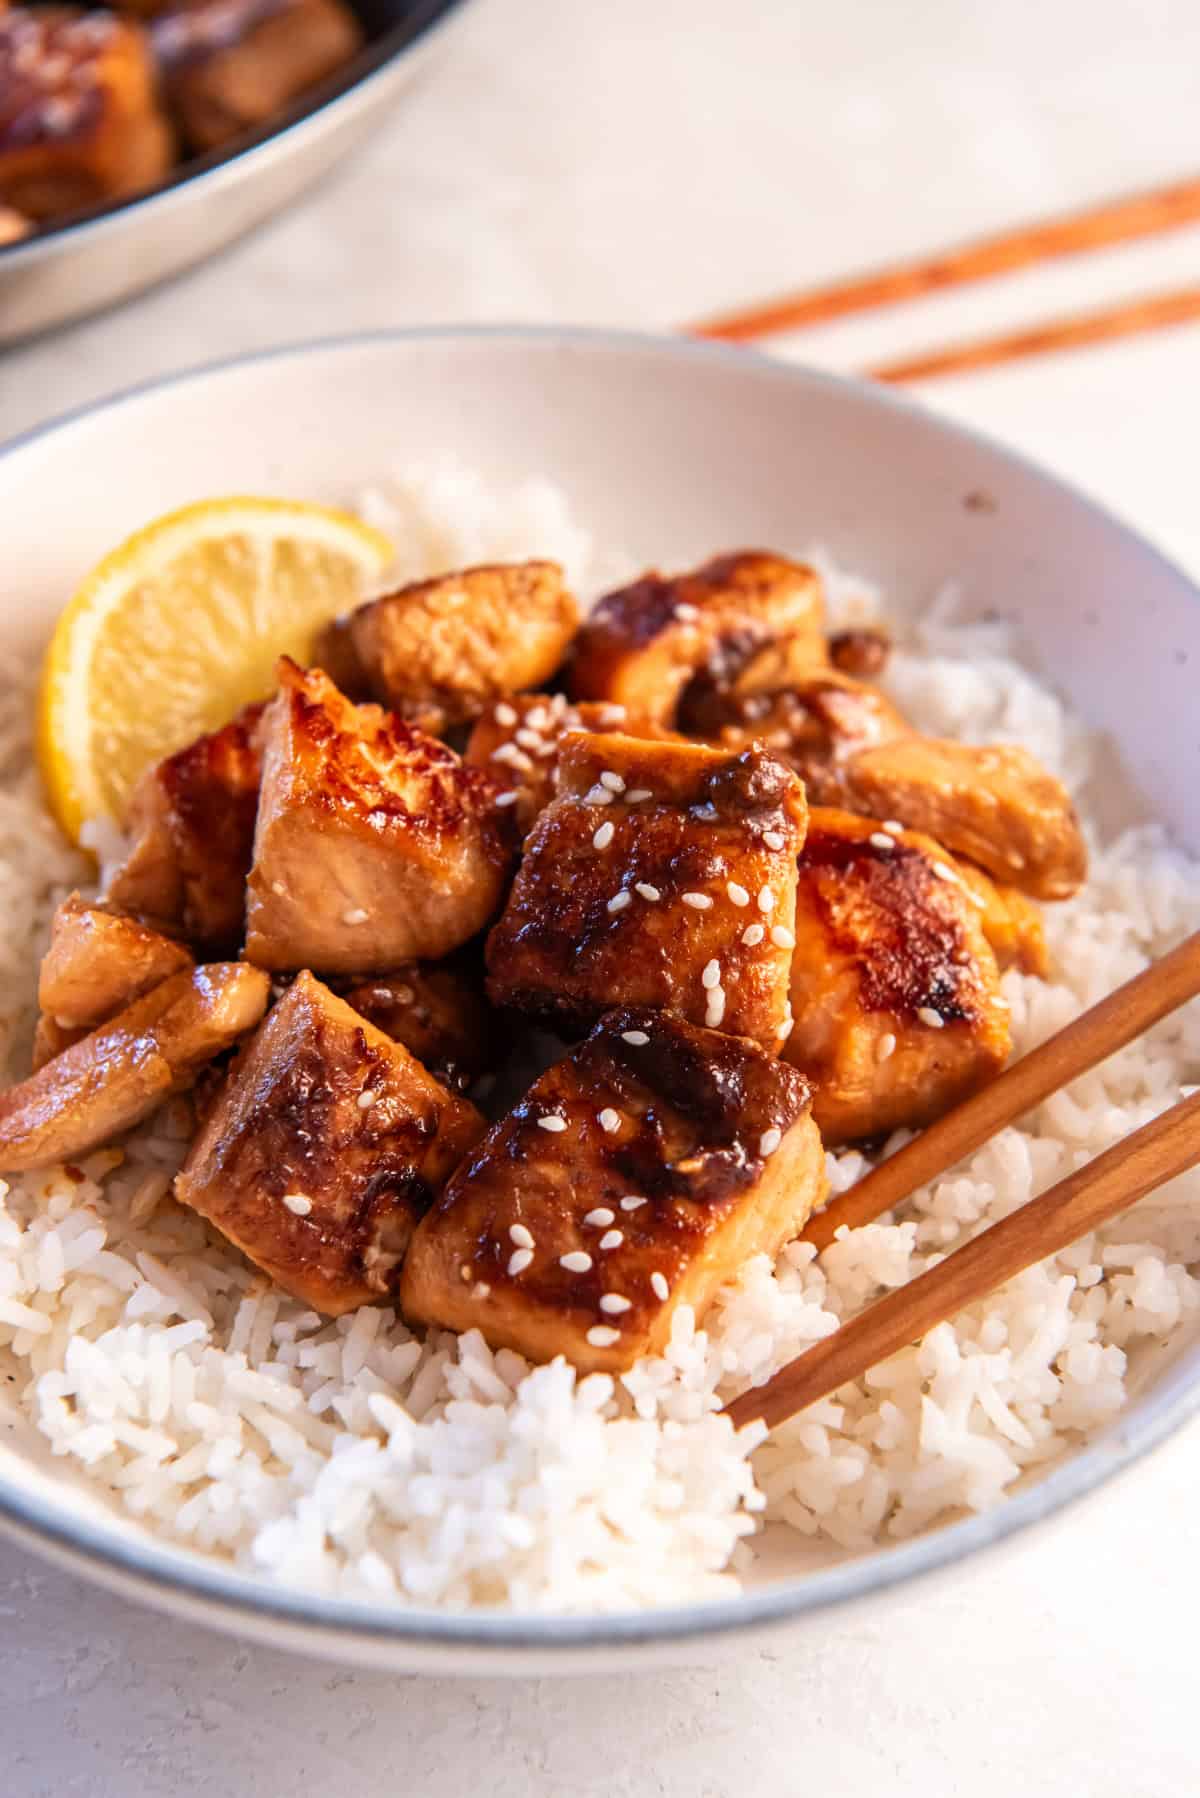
[0,0,1200,1798]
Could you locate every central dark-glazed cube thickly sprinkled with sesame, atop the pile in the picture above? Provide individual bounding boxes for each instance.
[488,732,806,1052]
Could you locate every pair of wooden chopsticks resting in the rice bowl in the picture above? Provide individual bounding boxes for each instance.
[725,931,1200,1428]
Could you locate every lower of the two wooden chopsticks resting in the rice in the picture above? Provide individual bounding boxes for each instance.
[725,1093,1200,1429]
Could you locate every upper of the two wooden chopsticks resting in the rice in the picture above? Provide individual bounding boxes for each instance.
[802,931,1200,1248]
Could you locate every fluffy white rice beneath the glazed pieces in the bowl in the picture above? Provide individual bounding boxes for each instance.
[0,469,1200,1613]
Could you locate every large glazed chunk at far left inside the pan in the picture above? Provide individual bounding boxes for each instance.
[0,5,175,219]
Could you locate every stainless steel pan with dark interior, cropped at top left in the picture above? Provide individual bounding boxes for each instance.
[0,0,464,345]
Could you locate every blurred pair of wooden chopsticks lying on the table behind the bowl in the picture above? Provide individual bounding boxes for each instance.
[687,178,1200,383]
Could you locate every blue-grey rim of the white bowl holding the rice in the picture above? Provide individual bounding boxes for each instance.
[0,327,1200,1661]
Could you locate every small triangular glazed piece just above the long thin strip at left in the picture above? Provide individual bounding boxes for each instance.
[34,894,193,1068]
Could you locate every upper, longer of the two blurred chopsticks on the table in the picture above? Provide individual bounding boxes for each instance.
[685,176,1200,343]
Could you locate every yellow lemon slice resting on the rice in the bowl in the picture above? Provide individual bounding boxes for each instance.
[38,498,394,841]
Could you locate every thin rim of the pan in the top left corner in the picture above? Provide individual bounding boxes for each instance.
[0,0,468,277]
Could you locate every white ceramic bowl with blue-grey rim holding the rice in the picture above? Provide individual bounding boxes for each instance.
[0,331,1200,1672]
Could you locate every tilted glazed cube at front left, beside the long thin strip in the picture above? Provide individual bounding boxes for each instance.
[175,975,486,1316]
